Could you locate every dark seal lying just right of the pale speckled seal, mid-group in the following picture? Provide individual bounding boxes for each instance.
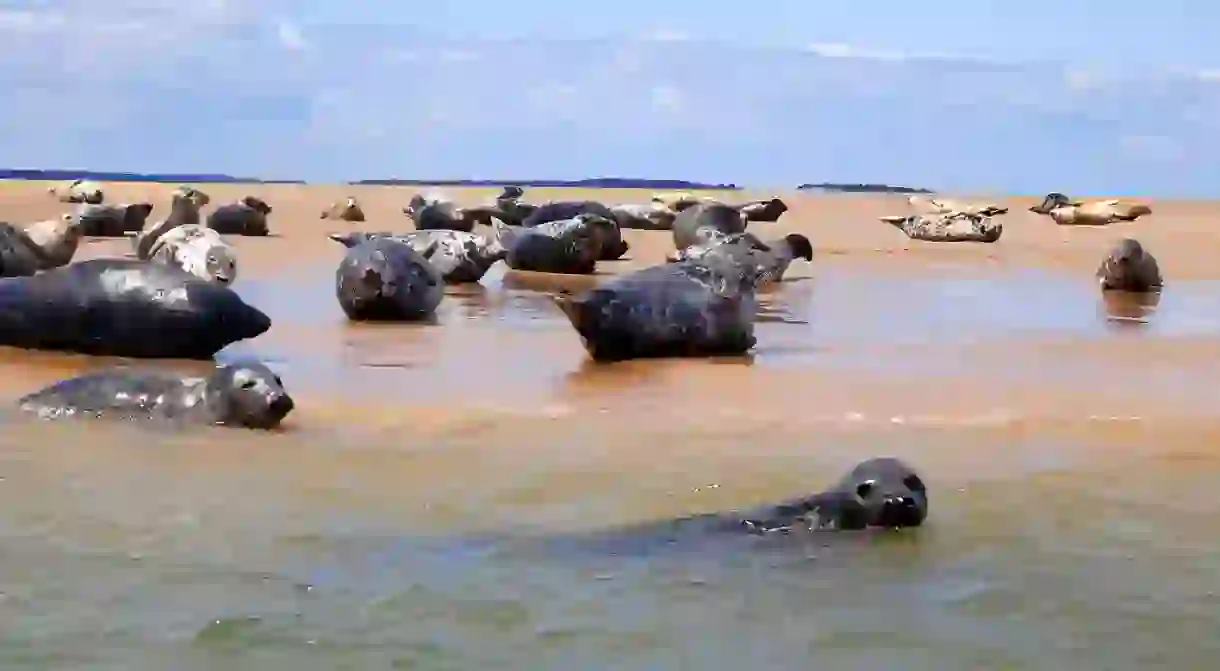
[495,214,617,275]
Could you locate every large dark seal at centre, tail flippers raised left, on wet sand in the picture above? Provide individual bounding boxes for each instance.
[555,256,758,361]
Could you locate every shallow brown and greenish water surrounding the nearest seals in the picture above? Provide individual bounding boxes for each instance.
[0,261,1220,670]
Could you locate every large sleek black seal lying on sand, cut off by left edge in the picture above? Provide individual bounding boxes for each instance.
[0,259,271,359]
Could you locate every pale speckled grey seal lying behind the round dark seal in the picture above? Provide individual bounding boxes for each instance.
[328,231,508,284]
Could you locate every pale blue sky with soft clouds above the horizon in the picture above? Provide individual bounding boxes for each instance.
[0,0,1220,198]
